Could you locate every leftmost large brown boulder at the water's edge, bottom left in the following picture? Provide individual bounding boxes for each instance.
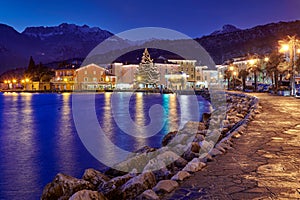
[41,173,95,200]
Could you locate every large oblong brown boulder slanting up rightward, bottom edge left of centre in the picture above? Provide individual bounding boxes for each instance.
[120,172,156,199]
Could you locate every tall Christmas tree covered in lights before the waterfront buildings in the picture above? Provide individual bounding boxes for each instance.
[135,48,159,88]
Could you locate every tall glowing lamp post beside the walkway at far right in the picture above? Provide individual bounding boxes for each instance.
[278,36,300,96]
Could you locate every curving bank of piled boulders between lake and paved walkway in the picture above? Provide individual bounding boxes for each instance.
[41,93,259,200]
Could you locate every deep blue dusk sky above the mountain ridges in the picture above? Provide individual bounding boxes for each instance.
[0,0,300,37]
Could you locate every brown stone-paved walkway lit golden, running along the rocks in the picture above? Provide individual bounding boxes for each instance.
[164,93,300,200]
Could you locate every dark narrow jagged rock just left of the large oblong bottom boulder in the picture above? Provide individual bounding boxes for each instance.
[98,173,135,199]
